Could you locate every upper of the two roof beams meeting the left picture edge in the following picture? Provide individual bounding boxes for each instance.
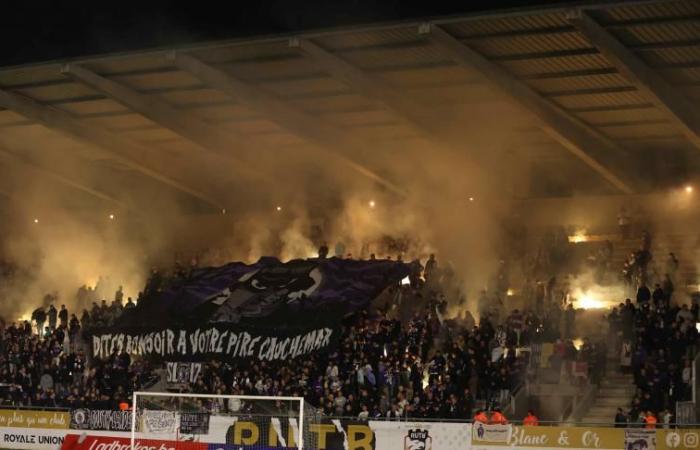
[0,89,222,210]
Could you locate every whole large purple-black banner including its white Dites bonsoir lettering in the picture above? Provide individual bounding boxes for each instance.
[90,258,416,361]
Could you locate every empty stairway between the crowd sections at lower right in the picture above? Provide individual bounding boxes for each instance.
[581,374,635,425]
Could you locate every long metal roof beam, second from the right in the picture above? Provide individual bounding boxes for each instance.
[419,24,634,194]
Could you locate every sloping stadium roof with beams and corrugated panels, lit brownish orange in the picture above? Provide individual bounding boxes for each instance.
[0,0,700,213]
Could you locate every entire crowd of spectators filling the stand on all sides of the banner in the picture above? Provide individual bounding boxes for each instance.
[0,229,698,426]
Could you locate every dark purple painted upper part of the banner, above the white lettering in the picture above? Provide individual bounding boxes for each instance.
[121,258,412,327]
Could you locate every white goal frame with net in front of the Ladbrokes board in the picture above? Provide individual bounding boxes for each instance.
[131,392,318,450]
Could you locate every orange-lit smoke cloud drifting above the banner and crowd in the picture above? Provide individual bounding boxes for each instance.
[0,67,556,319]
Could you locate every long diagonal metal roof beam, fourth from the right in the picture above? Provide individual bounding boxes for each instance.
[168,52,405,195]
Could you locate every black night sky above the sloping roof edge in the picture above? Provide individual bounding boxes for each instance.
[0,0,584,65]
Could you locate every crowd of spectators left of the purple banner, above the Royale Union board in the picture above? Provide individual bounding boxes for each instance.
[0,308,154,409]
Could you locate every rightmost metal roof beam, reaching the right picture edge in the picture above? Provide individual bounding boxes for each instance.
[567,10,700,150]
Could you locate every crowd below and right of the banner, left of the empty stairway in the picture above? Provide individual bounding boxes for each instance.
[182,241,616,419]
